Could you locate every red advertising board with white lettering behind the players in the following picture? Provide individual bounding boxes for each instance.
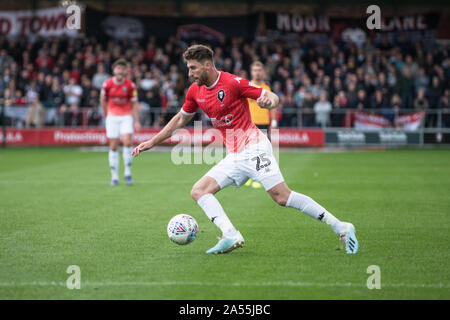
[0,128,325,147]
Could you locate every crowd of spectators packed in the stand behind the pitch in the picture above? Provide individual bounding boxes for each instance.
[0,31,450,127]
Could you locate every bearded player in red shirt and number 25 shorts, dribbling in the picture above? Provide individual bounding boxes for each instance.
[133,45,358,253]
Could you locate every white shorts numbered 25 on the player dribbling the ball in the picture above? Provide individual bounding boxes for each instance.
[205,135,284,191]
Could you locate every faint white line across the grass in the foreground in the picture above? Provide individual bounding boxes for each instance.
[0,281,450,289]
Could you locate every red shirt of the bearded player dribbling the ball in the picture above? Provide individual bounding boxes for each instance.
[181,71,264,153]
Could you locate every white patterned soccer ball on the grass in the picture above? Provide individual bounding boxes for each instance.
[167,214,198,244]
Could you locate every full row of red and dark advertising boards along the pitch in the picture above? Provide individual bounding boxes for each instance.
[0,128,450,147]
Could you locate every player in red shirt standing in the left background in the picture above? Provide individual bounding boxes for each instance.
[100,59,141,186]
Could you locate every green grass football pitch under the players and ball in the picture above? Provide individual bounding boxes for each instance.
[0,148,450,299]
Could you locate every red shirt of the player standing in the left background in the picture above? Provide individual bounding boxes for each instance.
[101,77,137,116]
